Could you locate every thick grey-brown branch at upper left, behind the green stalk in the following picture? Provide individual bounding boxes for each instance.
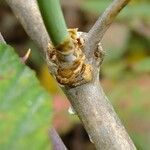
[6,0,50,51]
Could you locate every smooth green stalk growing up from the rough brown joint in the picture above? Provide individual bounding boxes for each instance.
[37,0,70,47]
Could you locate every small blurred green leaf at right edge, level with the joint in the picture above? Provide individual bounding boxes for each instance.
[133,57,150,73]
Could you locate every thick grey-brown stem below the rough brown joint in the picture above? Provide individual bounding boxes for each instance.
[64,77,136,150]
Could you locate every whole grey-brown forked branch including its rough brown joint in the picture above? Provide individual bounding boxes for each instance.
[6,0,136,150]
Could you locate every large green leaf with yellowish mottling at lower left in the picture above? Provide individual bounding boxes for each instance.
[0,44,51,150]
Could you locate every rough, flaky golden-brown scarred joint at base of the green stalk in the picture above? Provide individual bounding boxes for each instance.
[46,29,92,87]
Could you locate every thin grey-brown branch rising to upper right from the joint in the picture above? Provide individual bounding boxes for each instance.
[85,0,130,58]
